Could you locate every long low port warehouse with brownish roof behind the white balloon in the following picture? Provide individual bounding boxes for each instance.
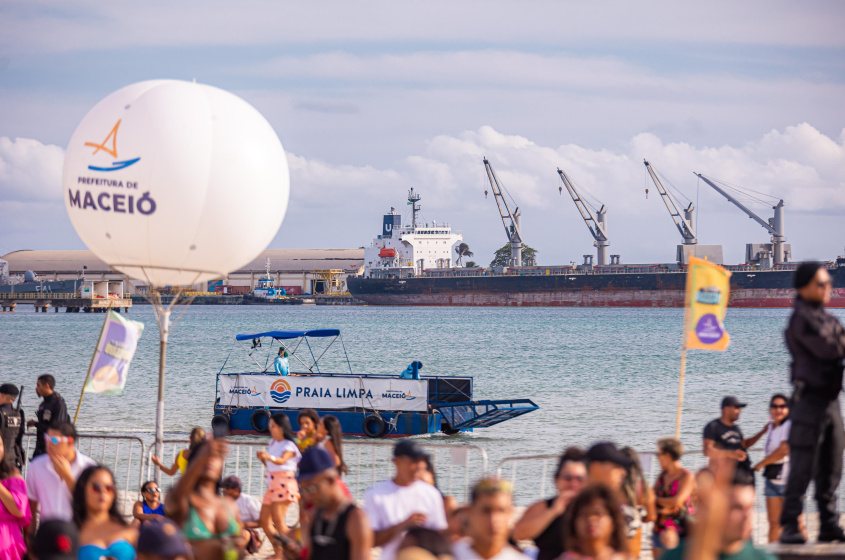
[0,248,364,294]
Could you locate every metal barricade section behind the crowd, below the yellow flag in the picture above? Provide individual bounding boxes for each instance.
[496,449,845,542]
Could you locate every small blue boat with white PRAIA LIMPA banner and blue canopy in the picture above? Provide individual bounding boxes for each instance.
[212,329,539,438]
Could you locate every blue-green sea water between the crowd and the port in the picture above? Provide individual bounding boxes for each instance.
[0,305,845,466]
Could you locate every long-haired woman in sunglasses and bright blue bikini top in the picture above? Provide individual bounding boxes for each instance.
[73,465,138,560]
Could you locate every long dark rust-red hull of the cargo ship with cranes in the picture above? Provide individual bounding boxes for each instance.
[347,267,845,308]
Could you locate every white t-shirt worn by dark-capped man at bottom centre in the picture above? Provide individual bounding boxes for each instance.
[364,480,447,560]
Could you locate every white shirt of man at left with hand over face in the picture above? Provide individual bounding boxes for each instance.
[26,451,97,521]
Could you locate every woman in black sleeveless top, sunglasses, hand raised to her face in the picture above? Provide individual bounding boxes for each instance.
[513,447,587,560]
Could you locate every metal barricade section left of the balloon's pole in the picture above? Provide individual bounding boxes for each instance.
[23,433,147,516]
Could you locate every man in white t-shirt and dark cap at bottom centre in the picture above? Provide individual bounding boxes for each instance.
[364,439,447,560]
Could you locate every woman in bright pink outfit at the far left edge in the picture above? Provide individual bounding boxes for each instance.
[0,439,32,560]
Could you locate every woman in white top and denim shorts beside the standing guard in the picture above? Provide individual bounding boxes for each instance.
[754,393,807,542]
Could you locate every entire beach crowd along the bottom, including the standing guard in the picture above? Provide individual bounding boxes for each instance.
[0,264,845,560]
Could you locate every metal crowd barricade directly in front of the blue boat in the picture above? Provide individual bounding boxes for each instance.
[144,436,487,503]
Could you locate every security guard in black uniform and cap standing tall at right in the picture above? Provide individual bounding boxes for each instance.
[780,263,845,544]
